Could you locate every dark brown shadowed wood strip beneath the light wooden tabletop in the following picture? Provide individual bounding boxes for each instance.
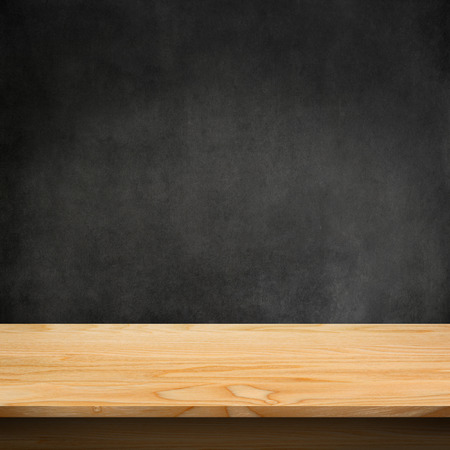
[0,418,450,450]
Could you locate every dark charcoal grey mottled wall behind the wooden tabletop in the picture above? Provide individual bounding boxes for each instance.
[0,0,450,323]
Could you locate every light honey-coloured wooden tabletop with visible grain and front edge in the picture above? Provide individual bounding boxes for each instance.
[0,324,450,417]
